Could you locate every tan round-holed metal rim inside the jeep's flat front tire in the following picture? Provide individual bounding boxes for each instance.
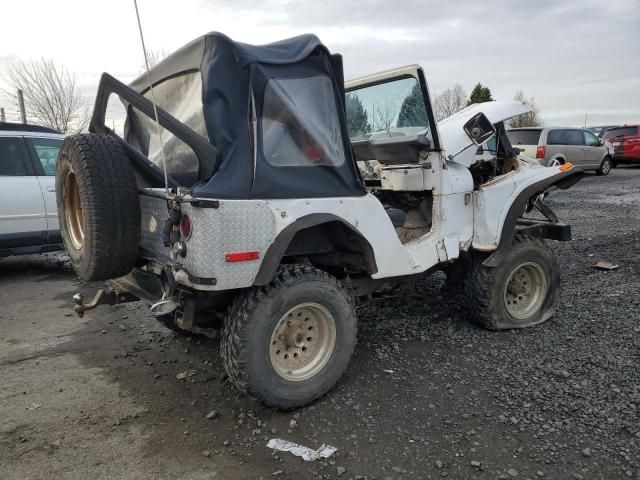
[504,262,547,320]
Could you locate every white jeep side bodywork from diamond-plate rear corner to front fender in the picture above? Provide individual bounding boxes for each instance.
[142,163,560,291]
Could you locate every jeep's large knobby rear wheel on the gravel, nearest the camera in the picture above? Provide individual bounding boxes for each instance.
[220,265,356,410]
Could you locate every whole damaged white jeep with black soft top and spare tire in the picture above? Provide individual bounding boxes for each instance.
[56,33,582,409]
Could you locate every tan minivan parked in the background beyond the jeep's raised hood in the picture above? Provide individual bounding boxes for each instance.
[507,127,613,175]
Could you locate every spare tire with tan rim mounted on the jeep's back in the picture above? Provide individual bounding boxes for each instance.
[56,133,140,281]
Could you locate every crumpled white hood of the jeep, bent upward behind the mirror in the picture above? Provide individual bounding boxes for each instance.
[438,101,531,167]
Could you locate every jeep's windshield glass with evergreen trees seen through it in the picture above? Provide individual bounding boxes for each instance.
[346,77,429,141]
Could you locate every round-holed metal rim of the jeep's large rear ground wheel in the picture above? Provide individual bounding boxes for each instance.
[269,303,336,382]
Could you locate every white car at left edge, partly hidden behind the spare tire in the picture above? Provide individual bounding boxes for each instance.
[0,123,64,257]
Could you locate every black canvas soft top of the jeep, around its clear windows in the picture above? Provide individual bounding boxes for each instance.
[130,32,364,198]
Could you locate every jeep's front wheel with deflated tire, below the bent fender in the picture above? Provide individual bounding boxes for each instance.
[465,236,560,330]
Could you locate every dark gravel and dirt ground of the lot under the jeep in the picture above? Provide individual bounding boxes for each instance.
[0,167,640,480]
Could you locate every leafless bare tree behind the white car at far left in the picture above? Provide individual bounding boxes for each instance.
[4,58,89,133]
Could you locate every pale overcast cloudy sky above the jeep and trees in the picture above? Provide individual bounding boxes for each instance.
[0,0,640,125]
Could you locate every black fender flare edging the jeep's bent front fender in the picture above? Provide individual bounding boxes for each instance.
[482,167,584,267]
